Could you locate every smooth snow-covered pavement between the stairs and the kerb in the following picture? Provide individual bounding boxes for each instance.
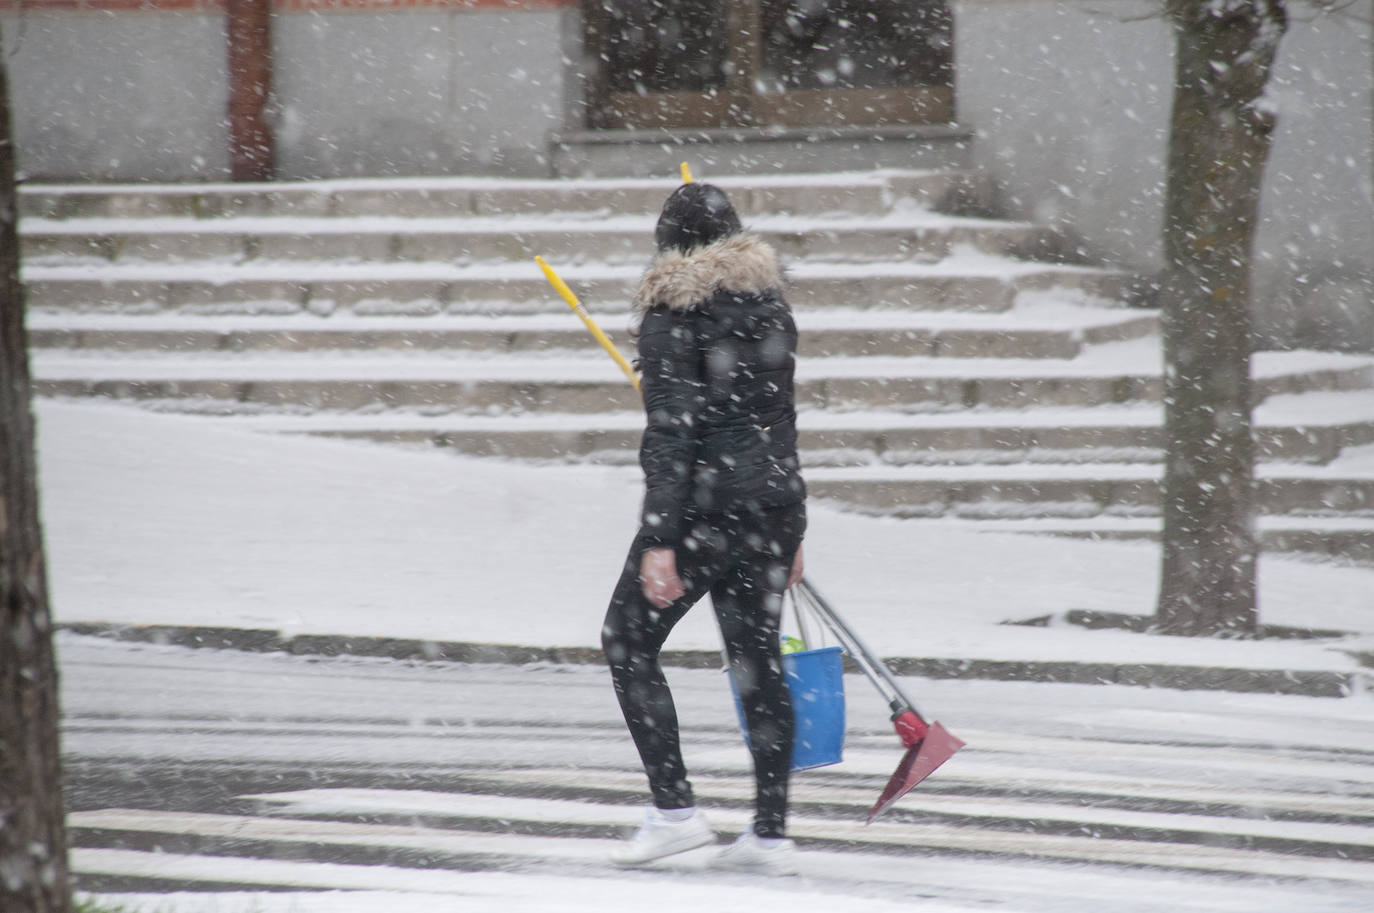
[37,403,1374,670]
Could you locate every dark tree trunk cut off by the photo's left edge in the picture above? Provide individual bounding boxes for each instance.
[0,23,71,913]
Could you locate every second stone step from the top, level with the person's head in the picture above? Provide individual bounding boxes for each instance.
[21,213,1068,267]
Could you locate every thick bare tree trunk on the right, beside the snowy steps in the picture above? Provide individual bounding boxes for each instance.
[1157,0,1287,635]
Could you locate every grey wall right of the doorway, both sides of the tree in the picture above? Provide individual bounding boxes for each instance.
[955,0,1374,351]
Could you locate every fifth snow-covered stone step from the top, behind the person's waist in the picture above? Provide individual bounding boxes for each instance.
[33,340,1374,413]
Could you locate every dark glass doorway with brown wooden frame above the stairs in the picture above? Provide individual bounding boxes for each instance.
[583,0,954,128]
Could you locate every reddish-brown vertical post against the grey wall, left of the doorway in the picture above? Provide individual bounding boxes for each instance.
[225,0,276,180]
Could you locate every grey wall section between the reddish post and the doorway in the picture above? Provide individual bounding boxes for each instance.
[273,7,567,177]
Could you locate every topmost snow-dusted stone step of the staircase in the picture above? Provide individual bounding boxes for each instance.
[19,162,992,219]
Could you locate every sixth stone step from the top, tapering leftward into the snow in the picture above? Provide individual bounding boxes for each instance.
[206,393,1374,469]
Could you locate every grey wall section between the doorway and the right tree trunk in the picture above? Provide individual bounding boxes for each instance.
[955,0,1172,267]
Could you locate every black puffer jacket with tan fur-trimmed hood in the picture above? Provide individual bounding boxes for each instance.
[636,234,807,546]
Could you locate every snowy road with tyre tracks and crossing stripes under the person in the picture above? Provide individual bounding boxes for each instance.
[59,635,1374,913]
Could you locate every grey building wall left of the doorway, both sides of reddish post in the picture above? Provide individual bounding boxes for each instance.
[0,0,576,180]
